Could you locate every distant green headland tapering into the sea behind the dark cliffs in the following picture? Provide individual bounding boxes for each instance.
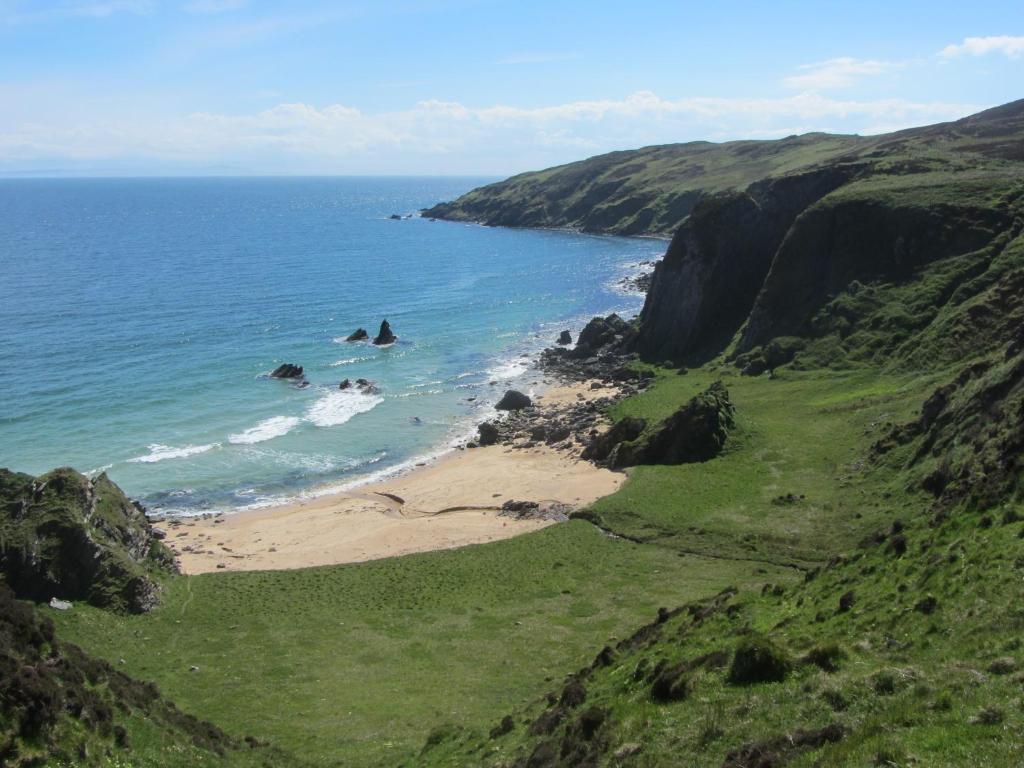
[424,101,1024,234]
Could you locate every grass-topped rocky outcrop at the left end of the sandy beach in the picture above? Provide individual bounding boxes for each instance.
[0,469,174,613]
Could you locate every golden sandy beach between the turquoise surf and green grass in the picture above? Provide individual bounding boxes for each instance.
[157,382,626,573]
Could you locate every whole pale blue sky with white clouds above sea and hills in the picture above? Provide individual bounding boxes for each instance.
[0,0,1024,176]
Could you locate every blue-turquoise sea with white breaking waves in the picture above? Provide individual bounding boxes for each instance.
[0,178,665,514]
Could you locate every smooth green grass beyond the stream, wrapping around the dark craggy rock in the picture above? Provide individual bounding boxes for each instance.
[593,368,941,564]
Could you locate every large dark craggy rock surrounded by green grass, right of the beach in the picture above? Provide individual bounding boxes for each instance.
[584,382,734,469]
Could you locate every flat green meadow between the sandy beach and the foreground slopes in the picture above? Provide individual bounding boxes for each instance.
[56,522,792,766]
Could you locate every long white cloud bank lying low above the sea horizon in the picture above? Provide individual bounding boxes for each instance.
[0,91,979,173]
